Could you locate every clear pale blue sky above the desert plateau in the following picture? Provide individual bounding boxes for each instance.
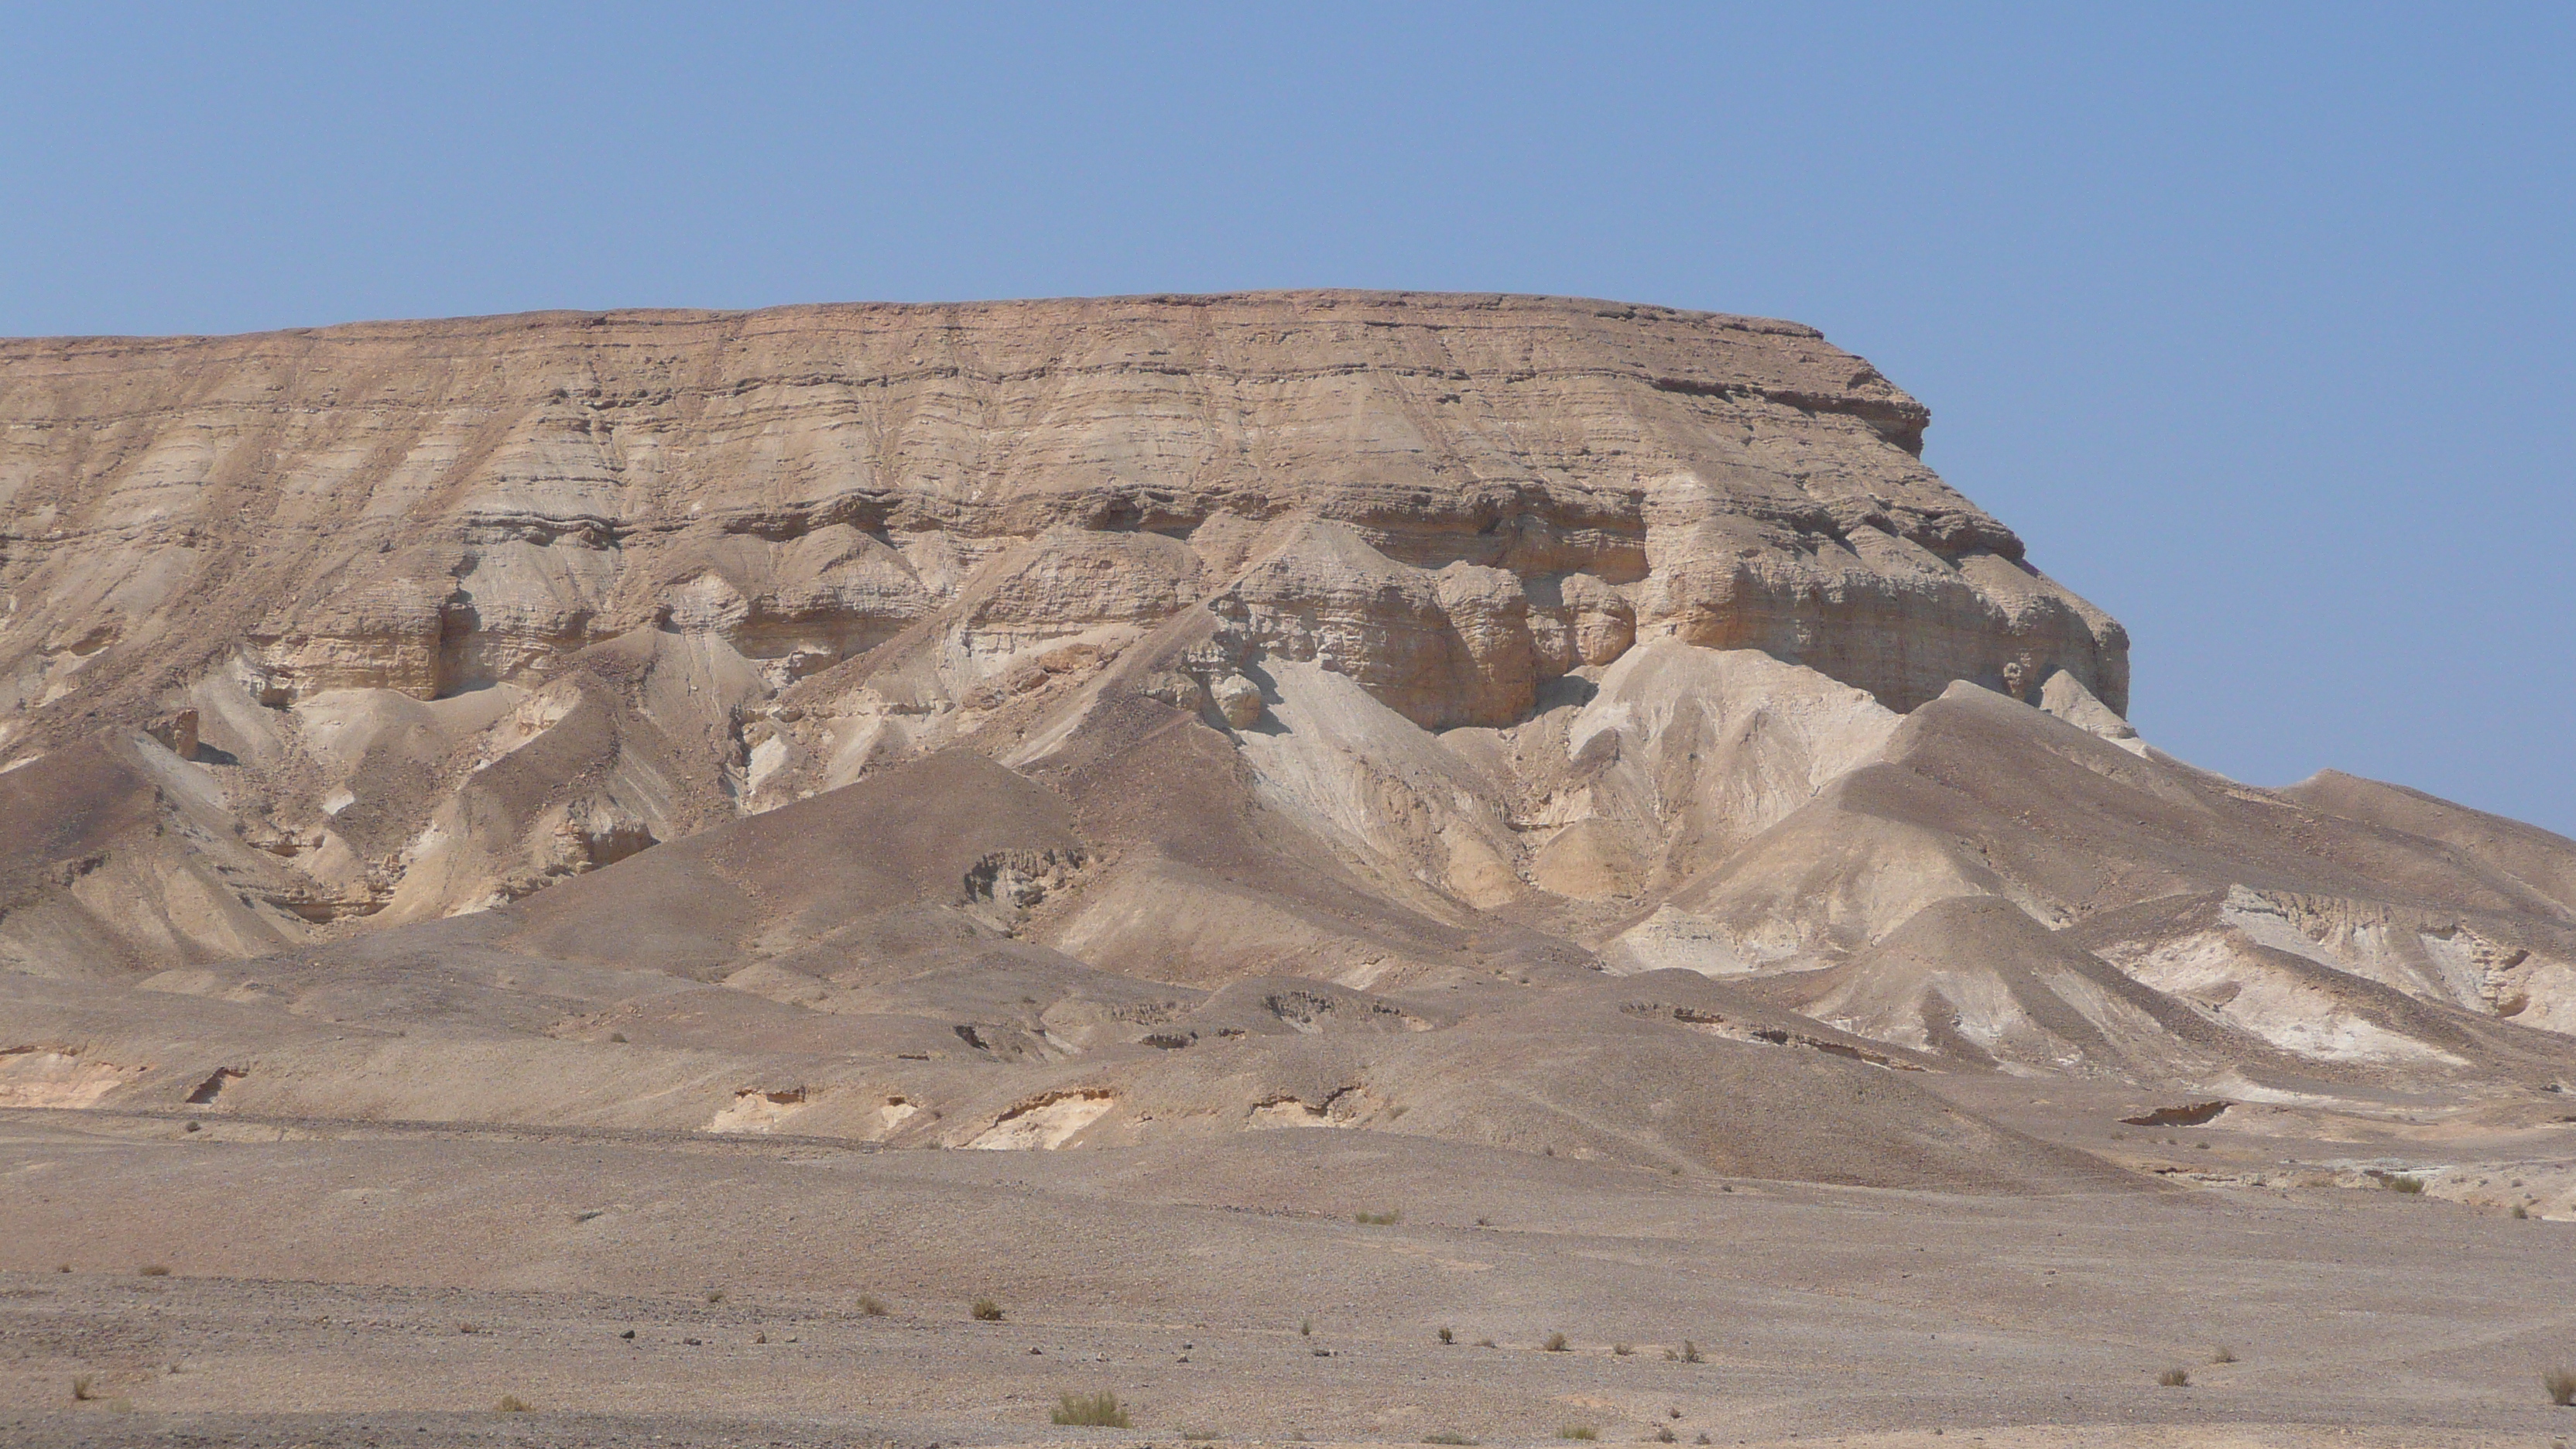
[0,2,2576,833]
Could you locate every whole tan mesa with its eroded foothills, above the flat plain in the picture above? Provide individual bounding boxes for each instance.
[0,294,2576,1160]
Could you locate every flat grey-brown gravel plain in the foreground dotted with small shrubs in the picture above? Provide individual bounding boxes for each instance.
[0,1112,2576,1447]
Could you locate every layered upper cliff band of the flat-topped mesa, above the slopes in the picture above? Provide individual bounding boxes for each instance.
[0,291,2128,732]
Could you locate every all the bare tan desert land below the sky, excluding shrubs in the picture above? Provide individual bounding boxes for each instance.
[0,294,2576,1444]
